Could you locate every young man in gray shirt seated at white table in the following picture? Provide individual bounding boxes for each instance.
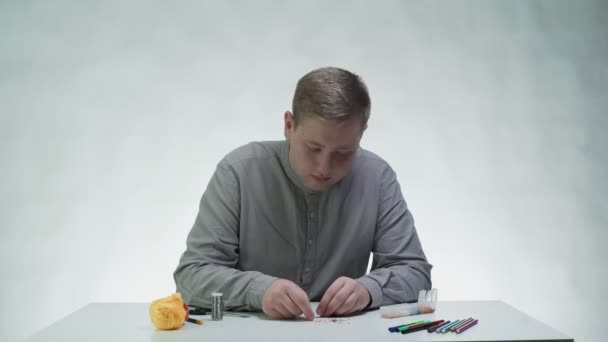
[174,68,432,320]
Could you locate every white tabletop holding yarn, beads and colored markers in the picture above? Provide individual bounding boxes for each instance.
[27,301,574,342]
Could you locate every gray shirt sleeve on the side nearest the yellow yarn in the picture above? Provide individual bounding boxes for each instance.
[173,163,276,310]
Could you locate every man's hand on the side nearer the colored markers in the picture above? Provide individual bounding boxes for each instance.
[317,277,371,316]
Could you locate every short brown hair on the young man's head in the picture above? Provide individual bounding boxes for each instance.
[292,67,371,126]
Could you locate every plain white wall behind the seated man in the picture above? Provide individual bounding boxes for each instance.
[0,1,608,341]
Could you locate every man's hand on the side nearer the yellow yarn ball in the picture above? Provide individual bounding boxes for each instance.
[262,279,315,321]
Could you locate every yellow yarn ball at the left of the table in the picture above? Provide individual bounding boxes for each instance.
[150,293,188,330]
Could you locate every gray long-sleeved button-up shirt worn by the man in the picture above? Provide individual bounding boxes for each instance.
[174,141,432,310]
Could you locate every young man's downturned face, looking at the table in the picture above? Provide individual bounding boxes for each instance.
[285,112,365,191]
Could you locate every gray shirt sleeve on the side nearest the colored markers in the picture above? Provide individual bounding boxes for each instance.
[357,167,432,308]
